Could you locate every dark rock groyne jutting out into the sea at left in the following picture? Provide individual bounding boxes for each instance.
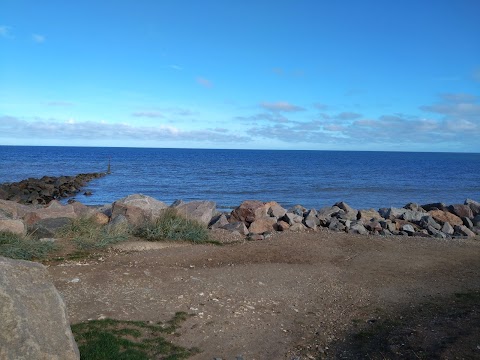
[0,173,106,205]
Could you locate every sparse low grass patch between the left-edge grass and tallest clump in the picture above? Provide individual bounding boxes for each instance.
[57,218,129,250]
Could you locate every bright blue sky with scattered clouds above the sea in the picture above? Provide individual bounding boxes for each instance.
[0,0,480,153]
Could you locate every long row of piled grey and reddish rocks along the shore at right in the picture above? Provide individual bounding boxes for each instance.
[210,199,480,240]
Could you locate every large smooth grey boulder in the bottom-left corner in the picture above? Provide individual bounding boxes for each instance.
[0,257,80,360]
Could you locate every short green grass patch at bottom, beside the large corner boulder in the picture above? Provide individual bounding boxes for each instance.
[72,312,199,360]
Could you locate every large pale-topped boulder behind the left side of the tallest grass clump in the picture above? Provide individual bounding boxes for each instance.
[112,194,167,226]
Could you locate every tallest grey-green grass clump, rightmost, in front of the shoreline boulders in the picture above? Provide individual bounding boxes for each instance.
[137,209,210,243]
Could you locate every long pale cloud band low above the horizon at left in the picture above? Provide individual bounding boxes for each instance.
[0,116,251,143]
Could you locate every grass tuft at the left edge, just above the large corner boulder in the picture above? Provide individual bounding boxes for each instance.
[0,231,57,260]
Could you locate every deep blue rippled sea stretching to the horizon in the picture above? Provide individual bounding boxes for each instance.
[0,146,480,210]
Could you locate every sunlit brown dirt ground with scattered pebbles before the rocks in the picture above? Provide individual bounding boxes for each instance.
[49,231,480,360]
